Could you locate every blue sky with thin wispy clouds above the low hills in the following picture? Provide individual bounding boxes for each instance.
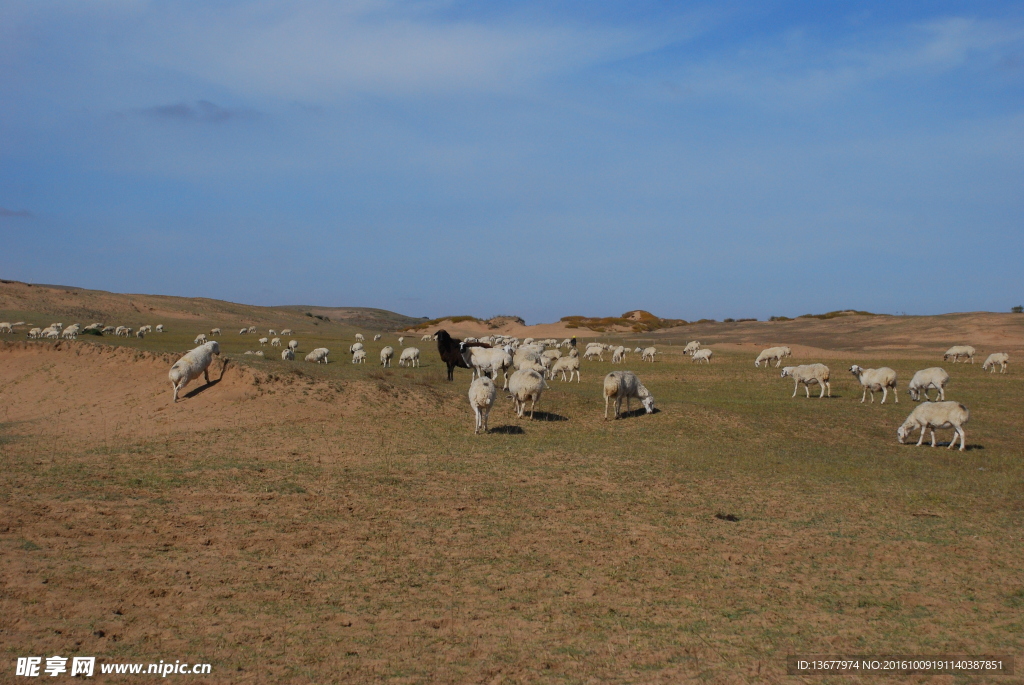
[0,0,1024,323]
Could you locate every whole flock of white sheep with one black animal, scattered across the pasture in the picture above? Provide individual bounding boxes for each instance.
[0,322,1010,451]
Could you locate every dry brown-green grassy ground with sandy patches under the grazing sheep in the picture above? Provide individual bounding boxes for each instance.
[0,282,1024,683]
